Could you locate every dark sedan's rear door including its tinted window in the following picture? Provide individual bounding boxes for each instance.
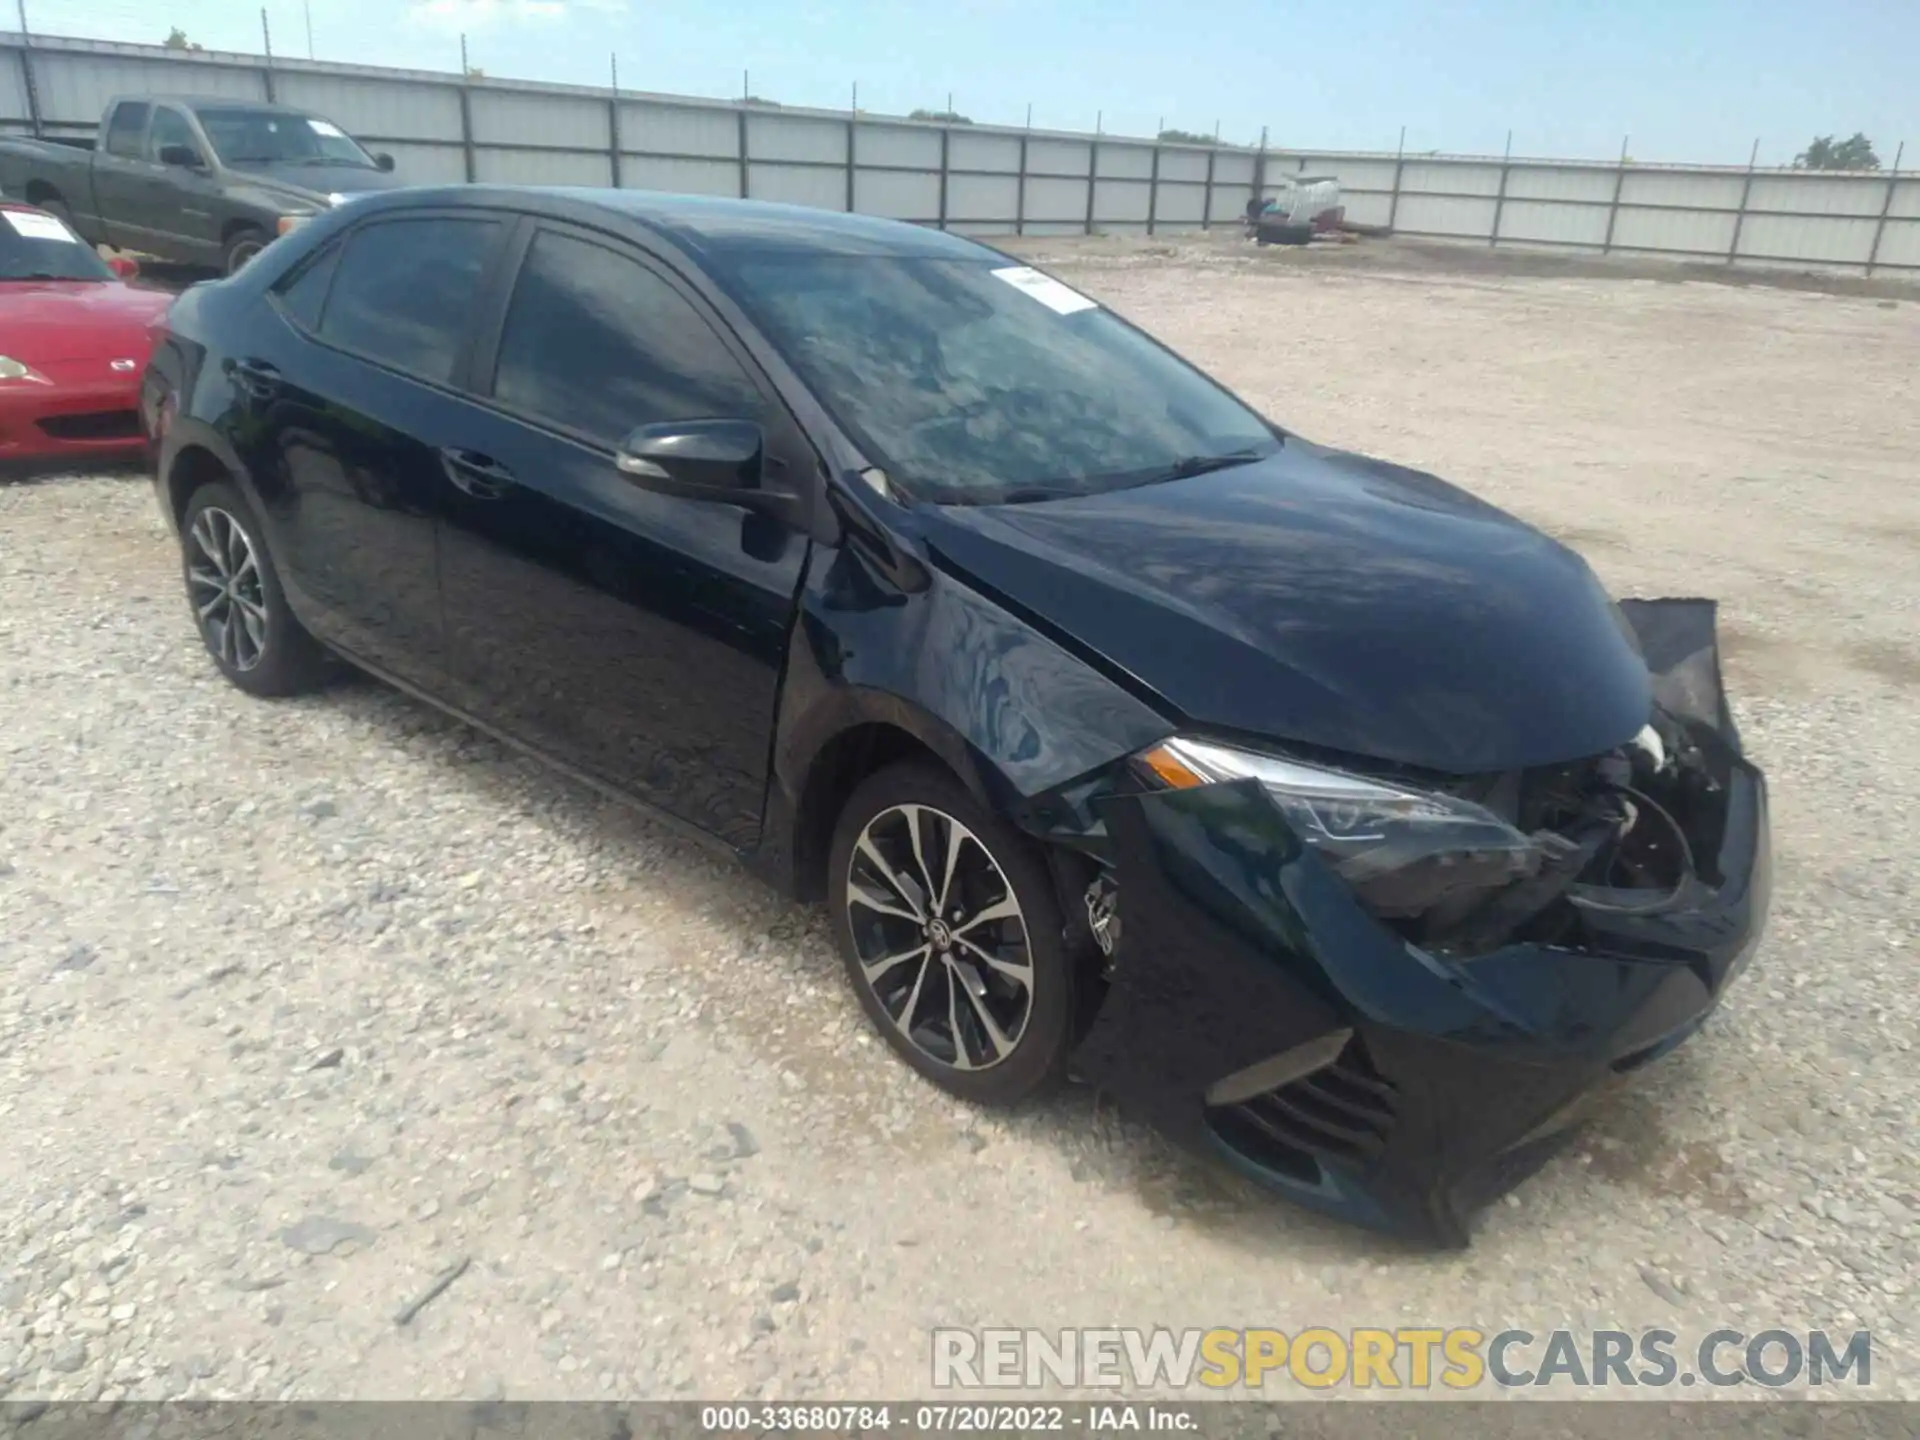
[228,209,511,695]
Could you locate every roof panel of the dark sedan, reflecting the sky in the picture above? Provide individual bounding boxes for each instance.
[376,184,1000,261]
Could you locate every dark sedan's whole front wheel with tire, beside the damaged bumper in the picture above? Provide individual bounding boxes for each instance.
[828,762,1079,1106]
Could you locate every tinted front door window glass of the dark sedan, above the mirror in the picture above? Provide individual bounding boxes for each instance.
[493,230,762,445]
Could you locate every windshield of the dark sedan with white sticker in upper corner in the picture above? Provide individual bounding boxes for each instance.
[728,253,1279,505]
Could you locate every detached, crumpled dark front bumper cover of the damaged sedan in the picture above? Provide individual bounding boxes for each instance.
[1077,601,1770,1244]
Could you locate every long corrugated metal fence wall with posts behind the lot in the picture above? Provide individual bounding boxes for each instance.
[0,35,1920,275]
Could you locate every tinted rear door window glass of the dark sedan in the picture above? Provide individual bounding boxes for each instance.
[314,215,499,382]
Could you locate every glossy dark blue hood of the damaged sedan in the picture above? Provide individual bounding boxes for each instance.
[924,438,1653,774]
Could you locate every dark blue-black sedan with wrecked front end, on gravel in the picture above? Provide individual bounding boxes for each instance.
[144,186,1768,1244]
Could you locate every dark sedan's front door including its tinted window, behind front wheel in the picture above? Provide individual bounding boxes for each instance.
[440,223,818,845]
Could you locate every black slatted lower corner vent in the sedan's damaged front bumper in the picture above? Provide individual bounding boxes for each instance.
[1210,1035,1398,1183]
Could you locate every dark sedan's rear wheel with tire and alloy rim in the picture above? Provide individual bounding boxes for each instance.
[180,480,326,697]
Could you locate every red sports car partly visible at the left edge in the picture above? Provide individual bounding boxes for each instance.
[0,200,173,470]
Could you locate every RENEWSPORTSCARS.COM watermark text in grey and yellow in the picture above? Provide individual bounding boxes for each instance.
[933,1327,1874,1390]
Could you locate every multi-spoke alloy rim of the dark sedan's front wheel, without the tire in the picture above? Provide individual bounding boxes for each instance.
[847,804,1033,1069]
